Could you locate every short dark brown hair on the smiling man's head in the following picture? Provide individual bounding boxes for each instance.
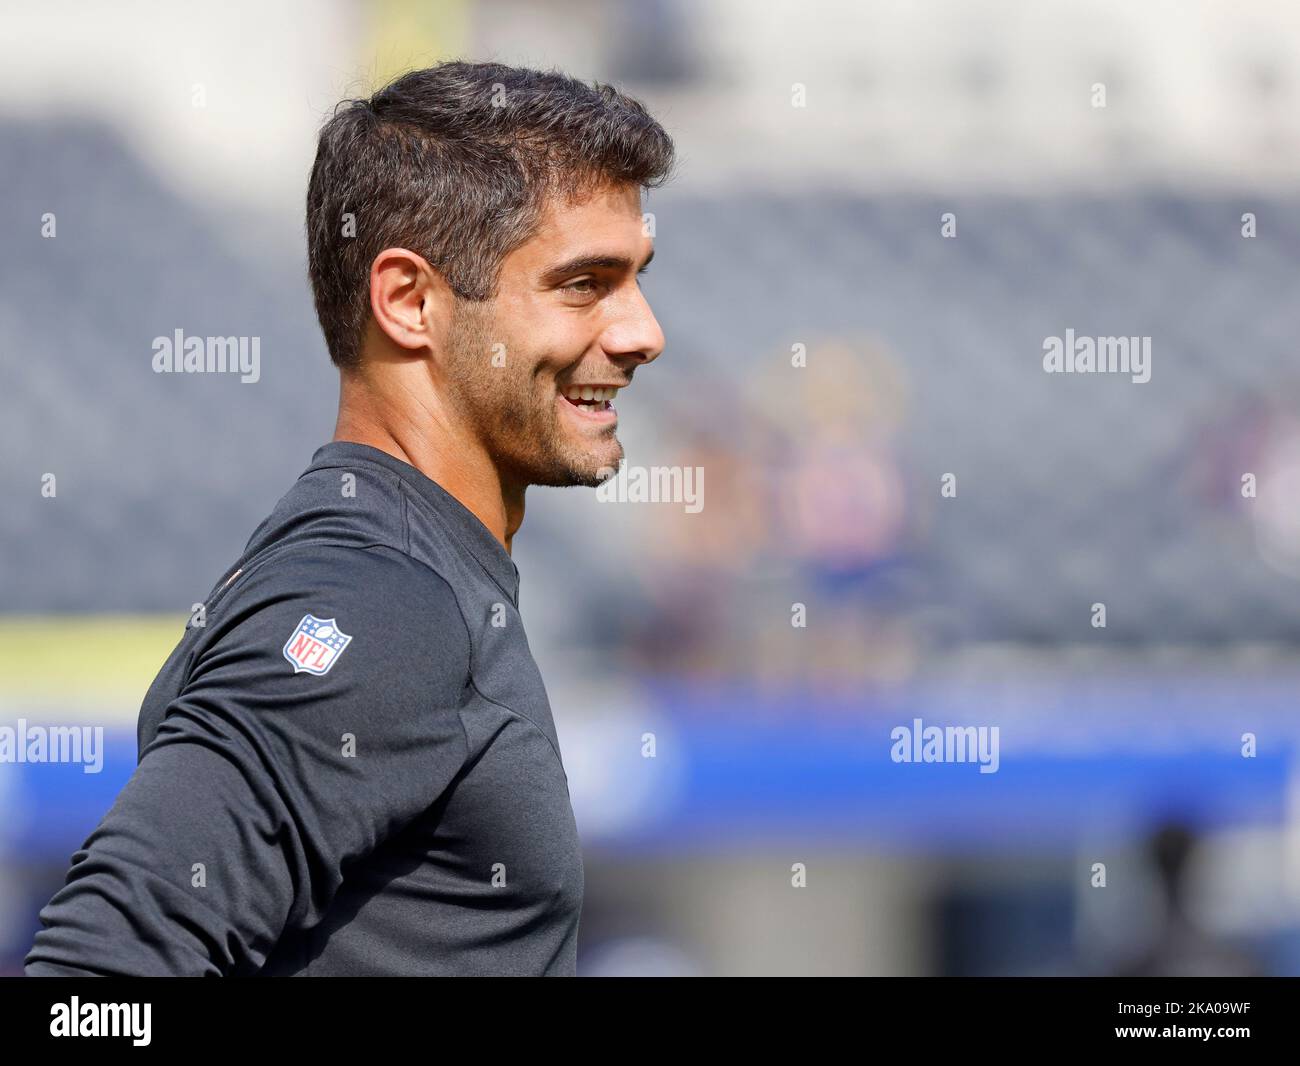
[307,62,673,368]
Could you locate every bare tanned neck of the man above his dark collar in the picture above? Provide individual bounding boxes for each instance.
[334,384,527,553]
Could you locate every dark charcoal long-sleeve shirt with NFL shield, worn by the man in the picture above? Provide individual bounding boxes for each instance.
[25,442,584,976]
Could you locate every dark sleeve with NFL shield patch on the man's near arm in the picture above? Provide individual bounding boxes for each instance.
[25,546,471,976]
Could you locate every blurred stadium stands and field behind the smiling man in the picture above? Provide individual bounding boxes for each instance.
[0,0,1300,975]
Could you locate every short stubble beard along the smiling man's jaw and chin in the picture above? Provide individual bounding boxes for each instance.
[450,302,623,488]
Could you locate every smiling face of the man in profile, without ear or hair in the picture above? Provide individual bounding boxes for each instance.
[449,186,664,485]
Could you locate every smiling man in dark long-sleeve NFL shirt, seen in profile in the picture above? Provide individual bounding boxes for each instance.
[26,62,673,976]
